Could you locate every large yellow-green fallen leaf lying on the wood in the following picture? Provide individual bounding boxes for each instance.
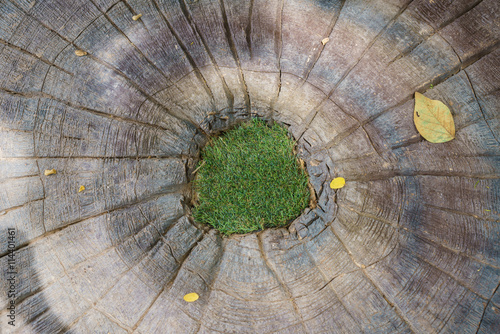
[413,92,455,143]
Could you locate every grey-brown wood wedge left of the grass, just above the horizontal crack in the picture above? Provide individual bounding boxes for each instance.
[34,99,196,157]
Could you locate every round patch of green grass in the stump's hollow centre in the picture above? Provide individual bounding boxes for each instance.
[193,119,309,235]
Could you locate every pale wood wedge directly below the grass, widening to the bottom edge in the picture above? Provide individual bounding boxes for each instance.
[195,235,304,333]
